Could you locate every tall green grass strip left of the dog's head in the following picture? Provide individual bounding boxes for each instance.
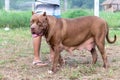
[0,10,31,28]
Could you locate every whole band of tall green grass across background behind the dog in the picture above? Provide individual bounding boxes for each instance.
[0,9,120,28]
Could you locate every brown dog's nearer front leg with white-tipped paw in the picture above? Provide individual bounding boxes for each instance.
[52,46,60,73]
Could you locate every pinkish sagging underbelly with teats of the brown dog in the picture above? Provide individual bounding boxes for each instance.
[61,38,95,53]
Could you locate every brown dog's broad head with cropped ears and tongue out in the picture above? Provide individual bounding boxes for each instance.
[30,12,48,35]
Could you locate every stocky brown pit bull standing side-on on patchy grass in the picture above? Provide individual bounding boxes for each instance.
[30,13,116,72]
